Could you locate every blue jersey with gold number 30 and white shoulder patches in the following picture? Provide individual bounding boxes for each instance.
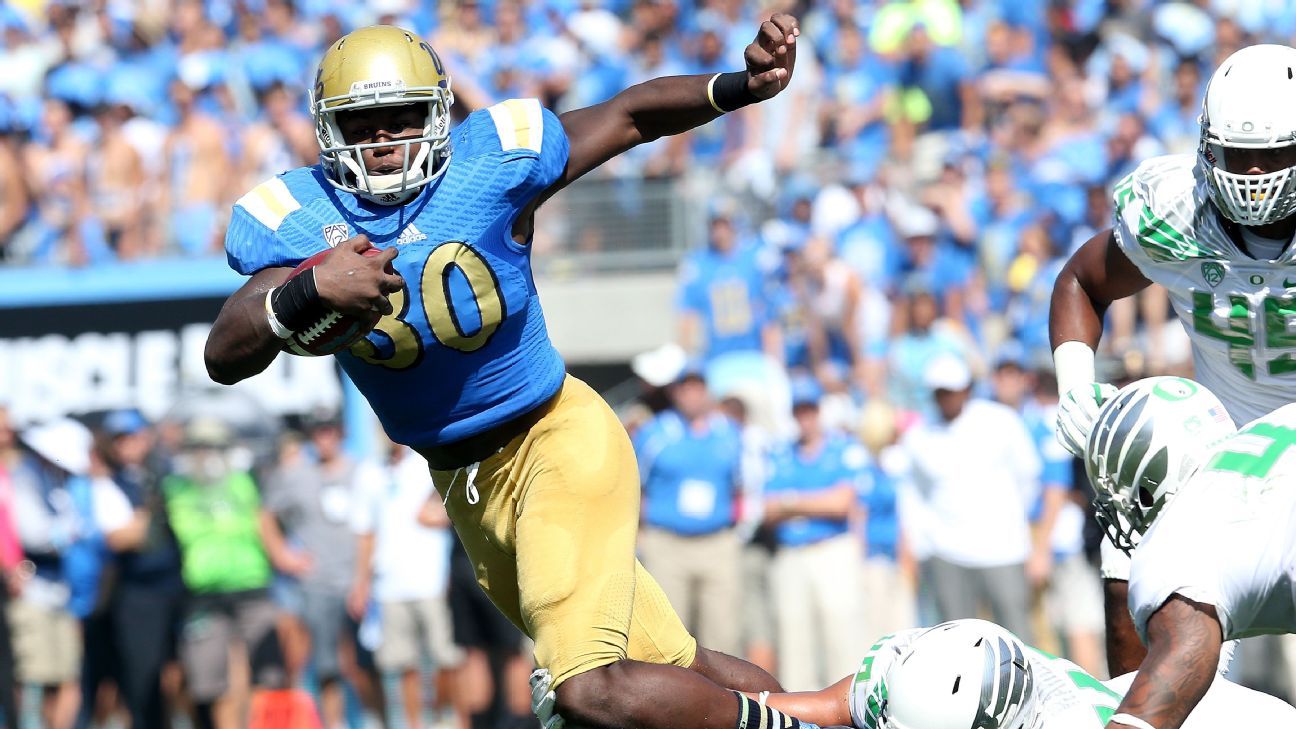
[226,99,568,446]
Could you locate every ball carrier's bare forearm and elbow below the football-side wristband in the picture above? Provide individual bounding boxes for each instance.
[202,269,292,385]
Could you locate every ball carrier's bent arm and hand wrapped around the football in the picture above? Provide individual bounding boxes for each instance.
[203,235,404,385]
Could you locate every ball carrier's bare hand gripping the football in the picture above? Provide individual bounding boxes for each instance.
[315,233,404,317]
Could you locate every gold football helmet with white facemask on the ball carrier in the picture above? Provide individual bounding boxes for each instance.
[311,26,455,205]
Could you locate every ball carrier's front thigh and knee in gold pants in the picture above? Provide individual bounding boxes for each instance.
[513,377,639,684]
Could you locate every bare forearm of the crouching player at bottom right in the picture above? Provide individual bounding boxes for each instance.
[1108,594,1223,729]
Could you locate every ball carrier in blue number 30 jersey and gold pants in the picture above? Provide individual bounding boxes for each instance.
[206,14,819,729]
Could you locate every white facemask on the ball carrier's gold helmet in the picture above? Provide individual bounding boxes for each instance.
[311,82,455,205]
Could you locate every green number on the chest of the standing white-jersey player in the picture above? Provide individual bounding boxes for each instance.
[1192,291,1296,380]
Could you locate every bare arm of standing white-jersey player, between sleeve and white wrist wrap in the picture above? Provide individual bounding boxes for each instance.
[1048,228,1151,349]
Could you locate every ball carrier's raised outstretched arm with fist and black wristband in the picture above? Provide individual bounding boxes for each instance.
[547,13,801,195]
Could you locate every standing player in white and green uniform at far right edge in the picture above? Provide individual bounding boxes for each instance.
[1050,39,1296,675]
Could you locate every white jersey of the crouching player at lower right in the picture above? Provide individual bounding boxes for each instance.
[1130,403,1296,642]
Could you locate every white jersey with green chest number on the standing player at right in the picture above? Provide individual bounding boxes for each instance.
[1115,154,1296,424]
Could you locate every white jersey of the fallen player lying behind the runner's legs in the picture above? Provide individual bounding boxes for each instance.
[848,628,1296,729]
